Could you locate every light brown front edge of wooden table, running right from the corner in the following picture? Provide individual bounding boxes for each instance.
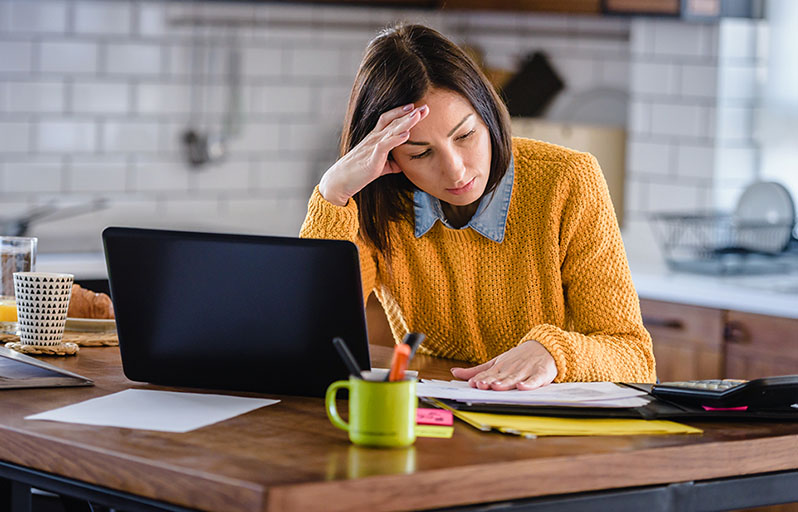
[265,435,798,512]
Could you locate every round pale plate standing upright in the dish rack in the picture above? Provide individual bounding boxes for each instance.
[734,181,795,253]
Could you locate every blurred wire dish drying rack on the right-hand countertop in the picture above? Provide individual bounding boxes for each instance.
[649,213,798,275]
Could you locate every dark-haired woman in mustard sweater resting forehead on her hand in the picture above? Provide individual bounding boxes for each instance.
[300,25,656,390]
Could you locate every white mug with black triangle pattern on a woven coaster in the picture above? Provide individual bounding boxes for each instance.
[14,272,75,347]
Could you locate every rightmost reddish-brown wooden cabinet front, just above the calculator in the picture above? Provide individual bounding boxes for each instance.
[726,311,798,379]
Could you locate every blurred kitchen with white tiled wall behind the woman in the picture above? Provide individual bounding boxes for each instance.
[0,0,798,380]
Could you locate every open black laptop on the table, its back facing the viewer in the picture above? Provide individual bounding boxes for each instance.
[102,227,370,396]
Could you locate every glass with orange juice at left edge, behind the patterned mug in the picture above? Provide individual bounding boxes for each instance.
[0,236,38,334]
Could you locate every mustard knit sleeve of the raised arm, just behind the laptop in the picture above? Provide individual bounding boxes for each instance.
[299,186,377,302]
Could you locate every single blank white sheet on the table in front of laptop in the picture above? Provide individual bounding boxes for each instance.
[25,389,279,432]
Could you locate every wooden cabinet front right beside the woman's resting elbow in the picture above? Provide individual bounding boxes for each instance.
[640,299,725,382]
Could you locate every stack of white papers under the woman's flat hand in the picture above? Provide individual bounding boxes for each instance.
[416,380,648,407]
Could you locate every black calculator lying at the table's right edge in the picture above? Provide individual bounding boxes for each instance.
[651,375,798,414]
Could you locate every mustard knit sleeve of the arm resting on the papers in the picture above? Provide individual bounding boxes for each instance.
[522,153,656,382]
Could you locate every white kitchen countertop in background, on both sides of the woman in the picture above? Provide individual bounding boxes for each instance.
[37,253,798,318]
